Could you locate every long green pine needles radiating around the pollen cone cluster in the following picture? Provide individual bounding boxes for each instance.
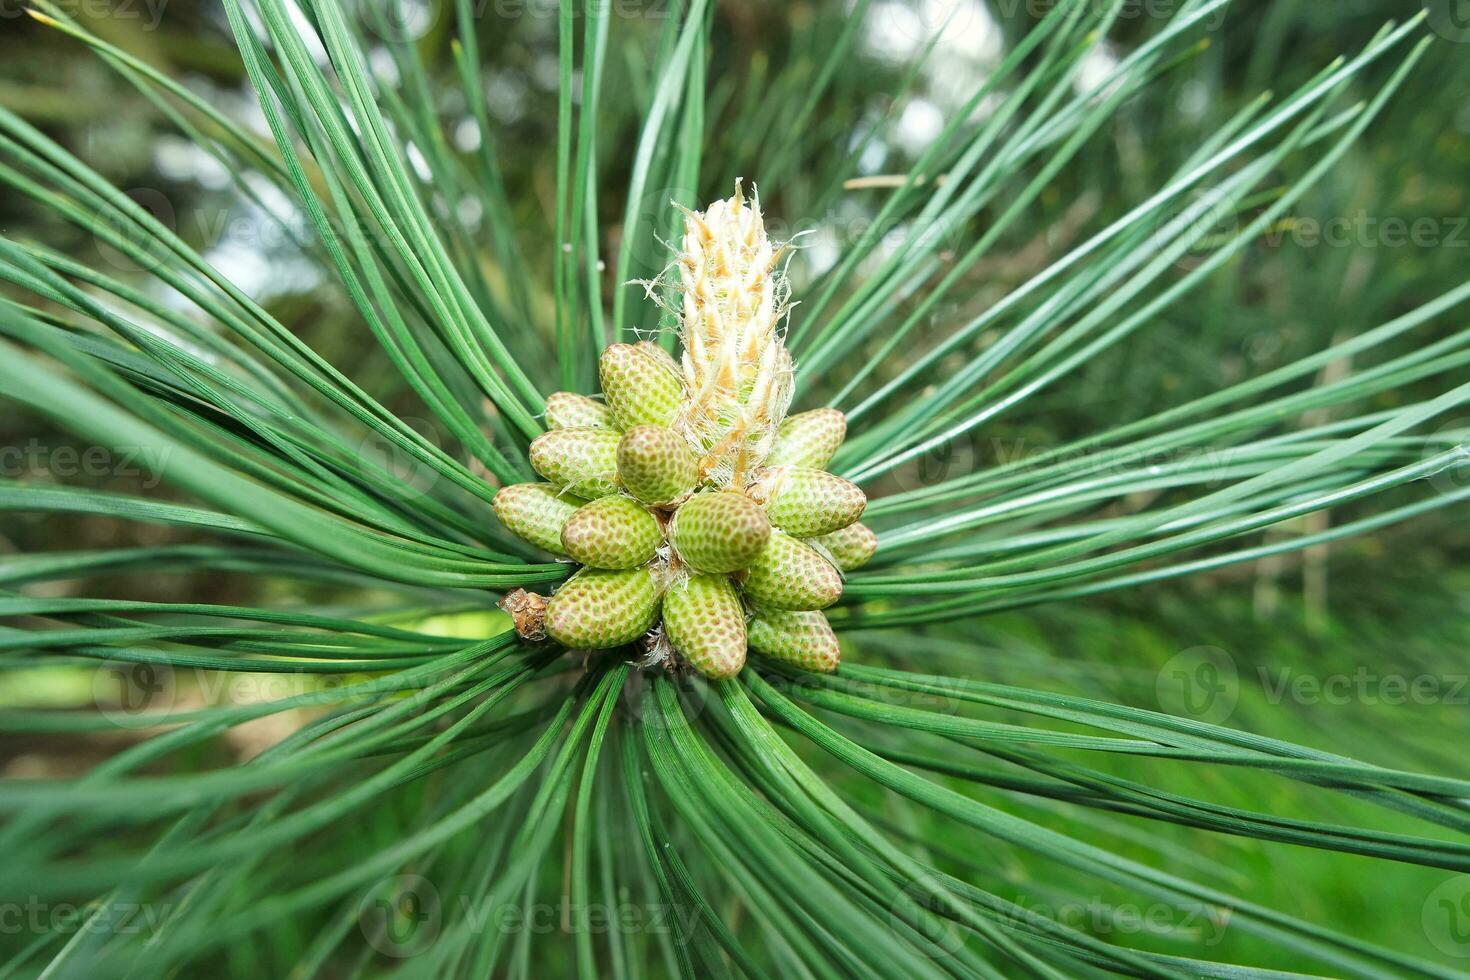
[0,0,1470,977]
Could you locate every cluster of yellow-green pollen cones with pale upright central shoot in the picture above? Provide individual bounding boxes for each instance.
[495,185,876,677]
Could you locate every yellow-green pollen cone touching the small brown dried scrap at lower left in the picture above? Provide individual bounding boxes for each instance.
[542,567,659,649]
